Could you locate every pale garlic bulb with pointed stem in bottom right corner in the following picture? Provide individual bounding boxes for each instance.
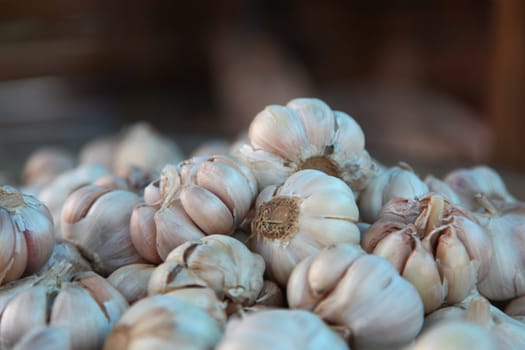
[423,292,525,350]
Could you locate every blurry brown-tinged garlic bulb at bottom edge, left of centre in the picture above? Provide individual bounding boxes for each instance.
[104,295,222,350]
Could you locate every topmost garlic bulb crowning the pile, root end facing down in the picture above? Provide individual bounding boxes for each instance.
[238,98,376,192]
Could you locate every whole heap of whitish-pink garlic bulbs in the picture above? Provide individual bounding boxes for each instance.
[0,98,525,350]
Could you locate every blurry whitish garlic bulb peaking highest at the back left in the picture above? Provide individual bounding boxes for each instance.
[113,122,184,172]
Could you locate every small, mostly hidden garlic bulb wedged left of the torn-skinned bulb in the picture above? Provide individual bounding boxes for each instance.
[107,264,155,305]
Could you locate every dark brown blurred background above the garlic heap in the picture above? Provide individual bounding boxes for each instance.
[0,0,525,190]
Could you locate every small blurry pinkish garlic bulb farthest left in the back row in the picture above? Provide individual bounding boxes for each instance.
[22,146,75,187]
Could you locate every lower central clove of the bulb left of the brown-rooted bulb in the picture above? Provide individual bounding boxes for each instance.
[180,184,234,234]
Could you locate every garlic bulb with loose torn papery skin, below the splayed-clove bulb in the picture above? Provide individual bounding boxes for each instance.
[148,235,265,305]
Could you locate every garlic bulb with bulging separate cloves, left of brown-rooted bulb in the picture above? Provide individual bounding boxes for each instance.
[130,156,257,263]
